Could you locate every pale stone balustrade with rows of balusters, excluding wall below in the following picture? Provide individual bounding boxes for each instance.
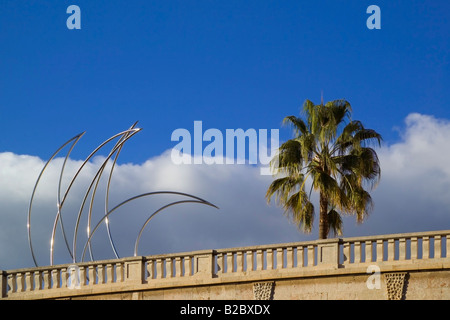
[0,230,450,299]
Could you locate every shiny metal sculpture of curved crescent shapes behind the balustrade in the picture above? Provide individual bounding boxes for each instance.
[27,122,218,267]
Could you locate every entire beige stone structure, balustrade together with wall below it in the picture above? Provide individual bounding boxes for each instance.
[0,231,450,300]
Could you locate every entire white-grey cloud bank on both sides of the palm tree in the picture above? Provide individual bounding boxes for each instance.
[0,114,450,269]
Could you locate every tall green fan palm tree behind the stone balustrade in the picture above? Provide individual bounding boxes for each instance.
[266,100,382,239]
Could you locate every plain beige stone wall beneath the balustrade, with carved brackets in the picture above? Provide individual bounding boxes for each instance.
[60,270,450,300]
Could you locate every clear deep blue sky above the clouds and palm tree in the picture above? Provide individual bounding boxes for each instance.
[0,0,450,162]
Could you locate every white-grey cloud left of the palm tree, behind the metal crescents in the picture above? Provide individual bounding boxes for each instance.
[0,151,305,269]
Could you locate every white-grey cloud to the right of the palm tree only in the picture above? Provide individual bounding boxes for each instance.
[342,113,450,235]
